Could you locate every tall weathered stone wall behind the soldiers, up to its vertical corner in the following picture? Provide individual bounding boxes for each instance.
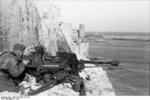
[0,0,60,55]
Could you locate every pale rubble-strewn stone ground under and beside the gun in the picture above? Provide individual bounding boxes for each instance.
[0,67,115,96]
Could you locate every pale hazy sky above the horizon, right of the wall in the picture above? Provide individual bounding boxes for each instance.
[54,0,150,32]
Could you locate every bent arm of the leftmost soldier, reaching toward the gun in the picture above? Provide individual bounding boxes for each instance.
[7,59,26,77]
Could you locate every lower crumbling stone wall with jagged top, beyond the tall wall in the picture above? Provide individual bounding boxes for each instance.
[58,23,89,59]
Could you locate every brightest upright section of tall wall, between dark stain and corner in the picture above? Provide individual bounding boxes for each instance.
[36,0,60,56]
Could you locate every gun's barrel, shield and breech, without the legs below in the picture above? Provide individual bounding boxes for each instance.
[24,52,119,76]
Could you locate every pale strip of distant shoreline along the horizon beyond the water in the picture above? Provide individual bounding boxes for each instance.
[85,32,150,41]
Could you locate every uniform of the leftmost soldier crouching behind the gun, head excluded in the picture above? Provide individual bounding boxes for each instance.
[0,44,25,92]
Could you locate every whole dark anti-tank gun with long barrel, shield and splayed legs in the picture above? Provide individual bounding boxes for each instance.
[24,46,119,95]
